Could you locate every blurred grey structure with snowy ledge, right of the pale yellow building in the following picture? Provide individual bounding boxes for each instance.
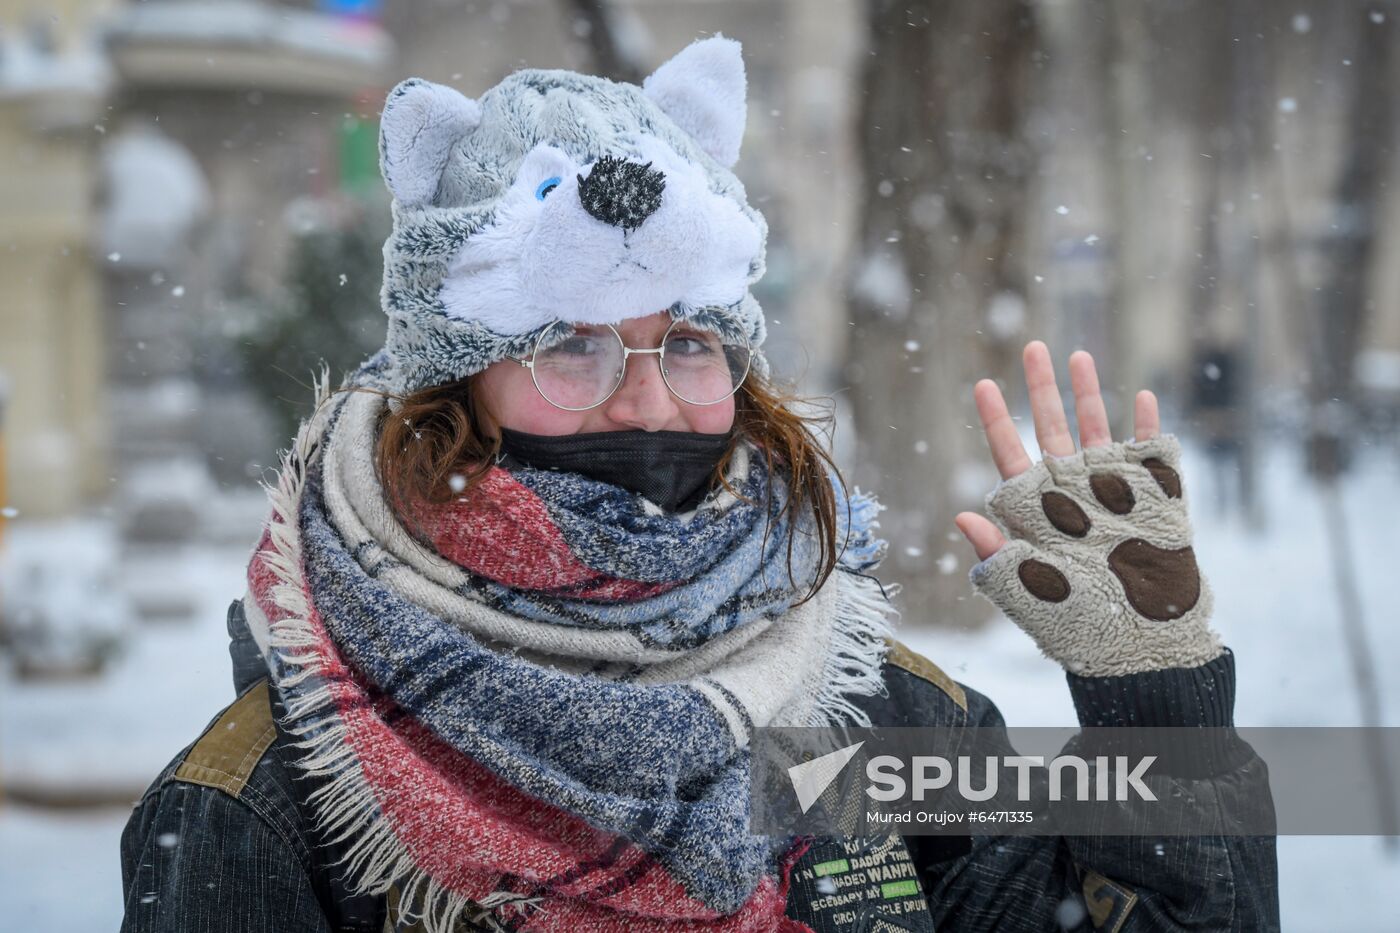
[101,0,393,541]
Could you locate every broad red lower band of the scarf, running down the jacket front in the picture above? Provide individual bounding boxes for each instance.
[249,534,811,933]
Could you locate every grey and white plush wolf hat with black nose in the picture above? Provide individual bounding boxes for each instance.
[374,35,767,394]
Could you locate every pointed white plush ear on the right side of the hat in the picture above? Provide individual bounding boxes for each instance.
[641,35,748,168]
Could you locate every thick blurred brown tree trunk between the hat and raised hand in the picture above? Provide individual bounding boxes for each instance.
[844,0,1036,623]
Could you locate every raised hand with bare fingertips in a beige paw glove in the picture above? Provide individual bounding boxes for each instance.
[955,340,1222,675]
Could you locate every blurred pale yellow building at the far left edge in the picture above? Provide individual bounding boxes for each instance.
[0,0,111,516]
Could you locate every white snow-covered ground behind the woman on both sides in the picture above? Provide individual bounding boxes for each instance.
[0,431,1400,933]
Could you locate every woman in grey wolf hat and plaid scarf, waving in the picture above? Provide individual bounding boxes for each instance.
[123,38,1277,932]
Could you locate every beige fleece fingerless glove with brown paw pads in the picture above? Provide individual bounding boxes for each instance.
[967,434,1224,677]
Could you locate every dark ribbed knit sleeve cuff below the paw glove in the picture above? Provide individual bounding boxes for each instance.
[1065,649,1254,778]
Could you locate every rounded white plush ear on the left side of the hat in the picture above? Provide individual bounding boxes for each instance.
[379,78,482,207]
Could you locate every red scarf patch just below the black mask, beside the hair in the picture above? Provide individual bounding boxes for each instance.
[414,467,676,602]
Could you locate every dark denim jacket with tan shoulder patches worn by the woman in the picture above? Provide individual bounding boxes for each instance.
[122,602,1280,933]
